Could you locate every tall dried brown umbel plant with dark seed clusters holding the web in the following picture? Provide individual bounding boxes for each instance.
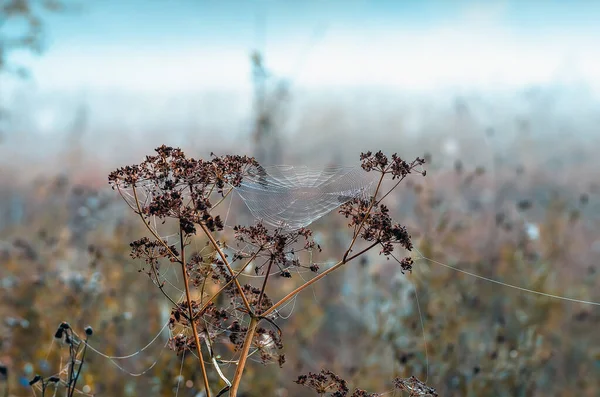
[109,146,424,397]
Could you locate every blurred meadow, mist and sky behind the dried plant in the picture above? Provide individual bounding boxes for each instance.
[0,0,600,396]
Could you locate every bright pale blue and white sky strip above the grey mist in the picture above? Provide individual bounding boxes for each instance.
[3,0,600,92]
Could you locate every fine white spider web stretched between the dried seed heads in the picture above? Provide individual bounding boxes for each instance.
[235,165,375,230]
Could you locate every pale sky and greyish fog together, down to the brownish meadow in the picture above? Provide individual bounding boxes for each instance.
[0,1,600,173]
